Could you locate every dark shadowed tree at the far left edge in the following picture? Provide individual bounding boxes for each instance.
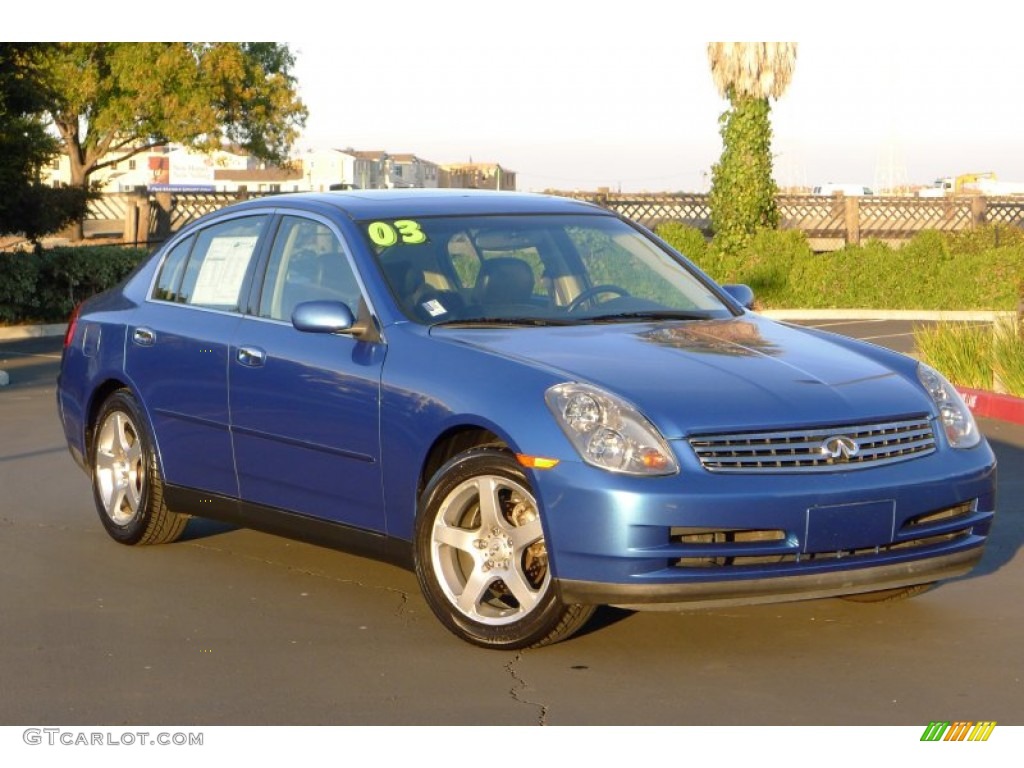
[0,43,87,241]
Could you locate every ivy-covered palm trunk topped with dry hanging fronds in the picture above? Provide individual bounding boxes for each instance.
[708,43,797,252]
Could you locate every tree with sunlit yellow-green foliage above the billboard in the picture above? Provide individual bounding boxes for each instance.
[38,43,306,239]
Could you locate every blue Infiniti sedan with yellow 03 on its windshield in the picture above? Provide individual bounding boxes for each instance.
[57,190,995,648]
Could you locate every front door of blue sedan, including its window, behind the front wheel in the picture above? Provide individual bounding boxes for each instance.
[228,215,385,531]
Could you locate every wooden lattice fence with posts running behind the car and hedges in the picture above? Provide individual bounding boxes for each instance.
[86,193,1024,251]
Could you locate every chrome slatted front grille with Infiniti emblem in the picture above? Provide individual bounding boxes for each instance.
[689,417,935,472]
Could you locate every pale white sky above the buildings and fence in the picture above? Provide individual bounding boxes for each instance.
[32,0,1024,191]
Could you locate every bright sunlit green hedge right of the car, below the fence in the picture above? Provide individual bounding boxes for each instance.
[657,222,1024,310]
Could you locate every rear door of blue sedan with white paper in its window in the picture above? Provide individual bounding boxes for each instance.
[125,214,270,497]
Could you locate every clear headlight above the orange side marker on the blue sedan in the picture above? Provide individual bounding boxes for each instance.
[544,383,679,475]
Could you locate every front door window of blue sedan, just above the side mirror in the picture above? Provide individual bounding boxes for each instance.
[259,216,361,322]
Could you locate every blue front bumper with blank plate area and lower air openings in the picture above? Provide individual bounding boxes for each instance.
[531,442,995,609]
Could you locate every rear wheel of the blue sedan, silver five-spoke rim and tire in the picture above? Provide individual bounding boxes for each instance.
[91,389,188,544]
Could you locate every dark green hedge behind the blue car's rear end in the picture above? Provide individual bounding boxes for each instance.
[0,246,147,325]
